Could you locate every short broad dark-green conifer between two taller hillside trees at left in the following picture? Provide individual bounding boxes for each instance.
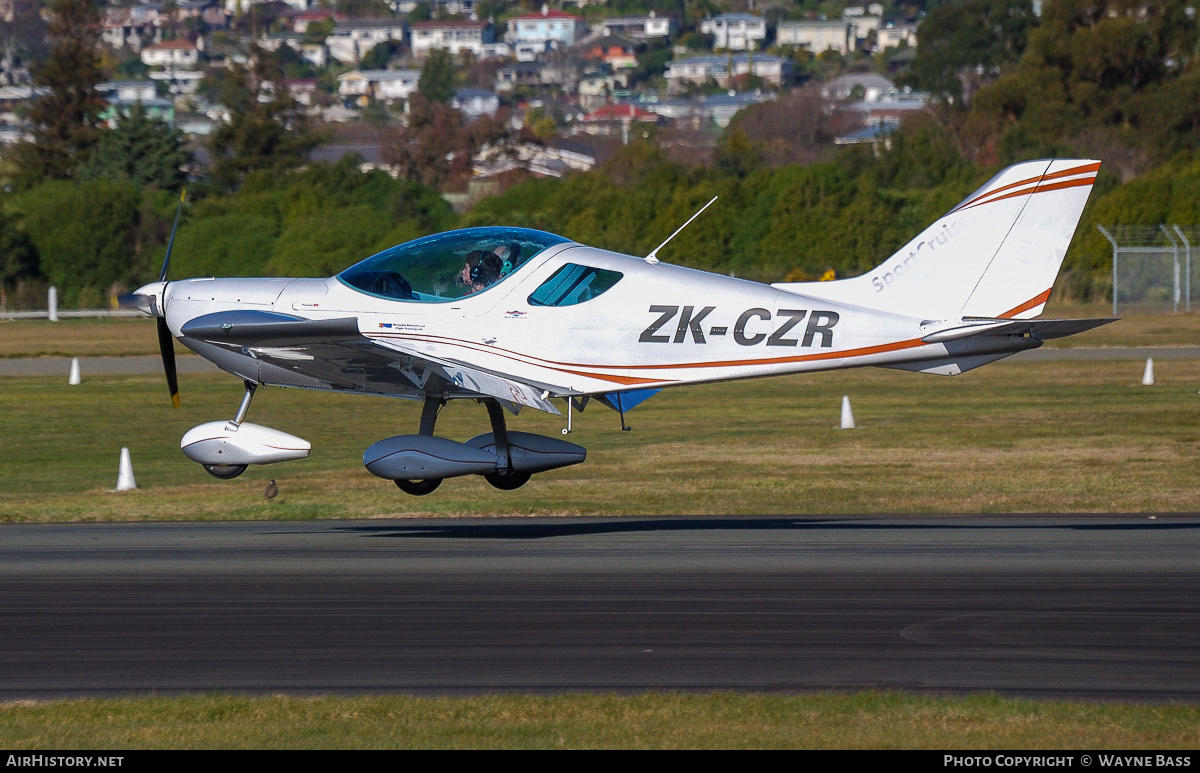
[79,102,192,190]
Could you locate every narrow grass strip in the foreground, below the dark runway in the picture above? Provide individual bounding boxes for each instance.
[0,693,1200,751]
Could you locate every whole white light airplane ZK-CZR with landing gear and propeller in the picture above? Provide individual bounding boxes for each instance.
[134,158,1112,495]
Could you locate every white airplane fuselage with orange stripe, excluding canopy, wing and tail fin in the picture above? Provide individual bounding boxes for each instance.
[166,242,1012,395]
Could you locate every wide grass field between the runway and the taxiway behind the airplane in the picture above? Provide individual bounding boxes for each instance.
[0,360,1200,521]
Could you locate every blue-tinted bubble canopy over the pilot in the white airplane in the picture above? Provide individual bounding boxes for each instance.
[337,228,570,302]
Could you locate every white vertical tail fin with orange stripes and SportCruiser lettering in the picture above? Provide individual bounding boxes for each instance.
[775,158,1100,319]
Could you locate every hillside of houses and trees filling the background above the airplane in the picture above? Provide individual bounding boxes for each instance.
[0,0,1200,306]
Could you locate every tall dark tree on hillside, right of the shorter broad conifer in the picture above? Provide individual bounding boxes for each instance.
[209,47,324,188]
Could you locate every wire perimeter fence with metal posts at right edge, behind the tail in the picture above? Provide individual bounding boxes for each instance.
[1097,223,1200,317]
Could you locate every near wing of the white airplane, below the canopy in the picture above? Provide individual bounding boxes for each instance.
[180,311,560,415]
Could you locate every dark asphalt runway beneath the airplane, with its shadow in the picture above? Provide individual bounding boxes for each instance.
[0,516,1200,702]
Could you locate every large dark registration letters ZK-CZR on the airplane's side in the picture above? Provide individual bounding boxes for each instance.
[637,305,841,349]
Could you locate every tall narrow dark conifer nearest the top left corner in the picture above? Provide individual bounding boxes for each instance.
[5,0,104,188]
